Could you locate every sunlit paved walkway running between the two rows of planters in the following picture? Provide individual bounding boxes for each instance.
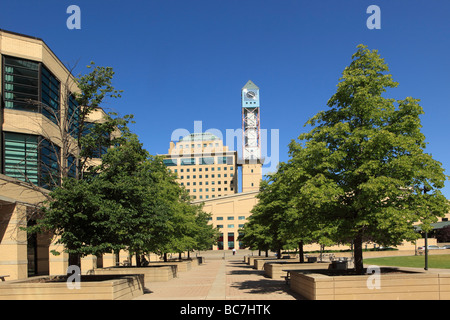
[132,252,302,300]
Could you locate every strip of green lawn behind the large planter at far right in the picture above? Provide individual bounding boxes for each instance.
[364,254,450,269]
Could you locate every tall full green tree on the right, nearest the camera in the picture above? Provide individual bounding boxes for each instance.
[290,45,448,272]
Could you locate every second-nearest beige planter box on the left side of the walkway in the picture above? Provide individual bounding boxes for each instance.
[94,265,178,283]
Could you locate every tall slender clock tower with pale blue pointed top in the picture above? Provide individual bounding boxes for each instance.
[241,80,263,192]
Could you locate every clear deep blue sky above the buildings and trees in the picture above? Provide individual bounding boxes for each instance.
[0,0,450,198]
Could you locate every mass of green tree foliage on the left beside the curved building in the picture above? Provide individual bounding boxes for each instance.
[28,63,217,256]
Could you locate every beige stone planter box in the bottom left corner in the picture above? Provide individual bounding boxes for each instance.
[0,274,144,300]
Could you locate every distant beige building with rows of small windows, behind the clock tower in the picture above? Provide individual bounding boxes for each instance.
[164,132,262,250]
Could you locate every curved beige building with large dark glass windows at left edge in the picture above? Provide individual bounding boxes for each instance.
[0,30,115,280]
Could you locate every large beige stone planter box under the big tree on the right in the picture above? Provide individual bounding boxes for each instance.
[290,268,450,300]
